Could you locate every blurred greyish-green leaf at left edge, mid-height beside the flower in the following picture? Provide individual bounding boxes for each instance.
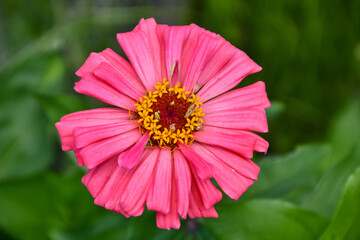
[0,92,53,181]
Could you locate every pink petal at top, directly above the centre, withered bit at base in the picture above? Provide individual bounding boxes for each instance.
[164,26,190,86]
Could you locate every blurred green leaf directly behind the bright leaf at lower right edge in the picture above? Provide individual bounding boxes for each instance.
[303,144,360,218]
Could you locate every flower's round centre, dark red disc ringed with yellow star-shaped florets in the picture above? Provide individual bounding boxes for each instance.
[135,78,205,149]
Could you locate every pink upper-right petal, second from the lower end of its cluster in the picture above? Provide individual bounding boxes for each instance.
[197,35,238,87]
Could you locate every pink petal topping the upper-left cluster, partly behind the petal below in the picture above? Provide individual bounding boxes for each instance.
[76,48,145,90]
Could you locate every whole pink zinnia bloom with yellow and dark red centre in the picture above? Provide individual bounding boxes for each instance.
[56,18,270,229]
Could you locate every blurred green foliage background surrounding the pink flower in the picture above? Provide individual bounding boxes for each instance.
[0,0,360,240]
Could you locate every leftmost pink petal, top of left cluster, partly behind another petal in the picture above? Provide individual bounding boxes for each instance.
[55,108,129,151]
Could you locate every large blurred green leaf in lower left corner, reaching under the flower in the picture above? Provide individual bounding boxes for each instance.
[0,171,128,239]
